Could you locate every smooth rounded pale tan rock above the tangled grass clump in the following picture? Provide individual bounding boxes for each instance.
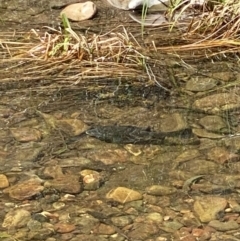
[60,1,97,21]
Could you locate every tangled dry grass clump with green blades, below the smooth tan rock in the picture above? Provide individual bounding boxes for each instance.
[28,26,147,65]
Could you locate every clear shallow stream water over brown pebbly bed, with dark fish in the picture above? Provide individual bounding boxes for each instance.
[0,1,240,241]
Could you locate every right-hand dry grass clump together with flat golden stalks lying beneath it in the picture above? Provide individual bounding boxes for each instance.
[151,0,240,58]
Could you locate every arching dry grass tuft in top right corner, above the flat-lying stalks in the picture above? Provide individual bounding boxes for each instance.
[166,0,240,40]
